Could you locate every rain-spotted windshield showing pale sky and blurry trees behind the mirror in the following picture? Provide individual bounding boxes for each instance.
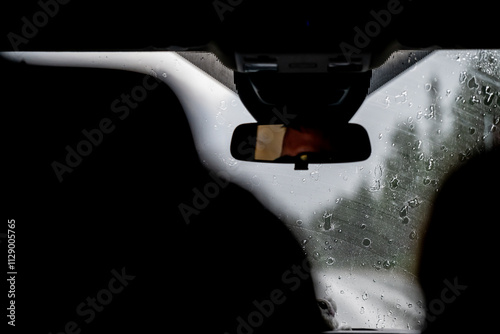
[4,50,500,330]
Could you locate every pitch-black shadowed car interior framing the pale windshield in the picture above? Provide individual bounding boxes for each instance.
[0,0,500,334]
